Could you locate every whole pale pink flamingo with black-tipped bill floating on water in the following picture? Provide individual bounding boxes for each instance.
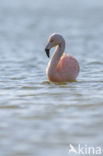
[45,33,80,82]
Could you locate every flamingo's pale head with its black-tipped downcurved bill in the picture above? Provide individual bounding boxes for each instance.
[45,33,65,57]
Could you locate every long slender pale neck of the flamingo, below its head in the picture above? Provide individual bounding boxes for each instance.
[48,41,65,74]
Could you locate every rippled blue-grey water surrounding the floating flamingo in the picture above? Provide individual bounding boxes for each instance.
[0,0,103,156]
